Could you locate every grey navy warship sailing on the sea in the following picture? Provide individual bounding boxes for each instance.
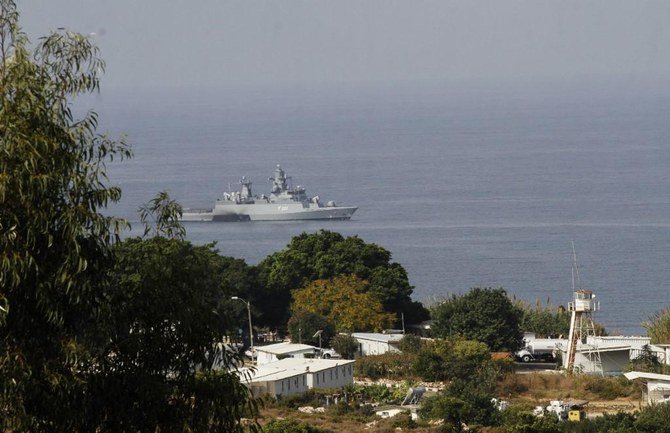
[182,164,358,221]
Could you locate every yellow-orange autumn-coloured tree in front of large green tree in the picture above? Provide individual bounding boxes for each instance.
[292,275,394,332]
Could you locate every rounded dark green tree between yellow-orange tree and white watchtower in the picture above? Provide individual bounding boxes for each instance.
[431,288,523,352]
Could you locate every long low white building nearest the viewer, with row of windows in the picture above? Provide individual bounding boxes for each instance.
[242,358,354,397]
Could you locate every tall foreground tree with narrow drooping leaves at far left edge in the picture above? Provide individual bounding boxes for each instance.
[0,0,130,431]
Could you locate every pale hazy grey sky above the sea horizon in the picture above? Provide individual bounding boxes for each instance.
[17,0,670,87]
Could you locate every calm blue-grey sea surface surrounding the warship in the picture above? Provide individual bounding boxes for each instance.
[98,80,670,334]
